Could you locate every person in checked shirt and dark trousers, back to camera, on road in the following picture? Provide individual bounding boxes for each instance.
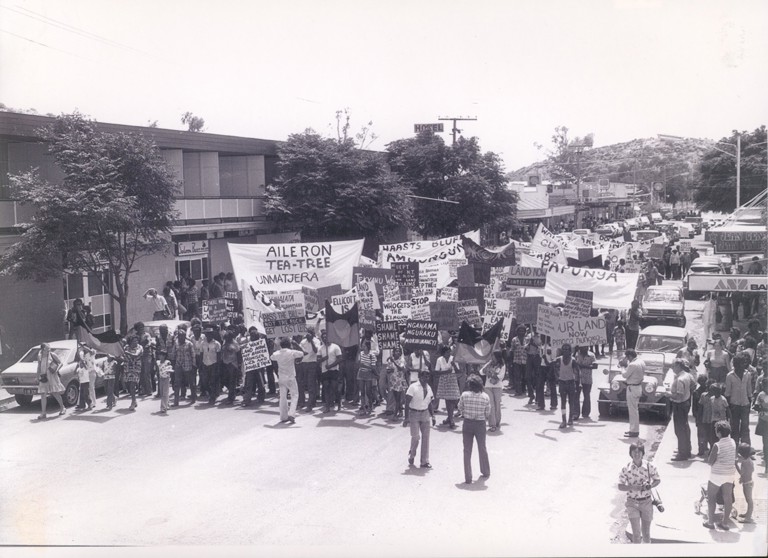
[459,376,488,484]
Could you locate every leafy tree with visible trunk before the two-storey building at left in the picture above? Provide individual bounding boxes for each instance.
[0,113,177,332]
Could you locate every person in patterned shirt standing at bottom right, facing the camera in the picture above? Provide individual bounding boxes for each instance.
[619,442,661,544]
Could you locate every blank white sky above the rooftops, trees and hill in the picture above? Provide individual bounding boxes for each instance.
[0,0,768,170]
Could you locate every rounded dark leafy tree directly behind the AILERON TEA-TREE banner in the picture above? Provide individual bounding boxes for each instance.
[266,130,411,245]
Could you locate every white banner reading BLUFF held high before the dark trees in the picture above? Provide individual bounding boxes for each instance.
[379,230,480,289]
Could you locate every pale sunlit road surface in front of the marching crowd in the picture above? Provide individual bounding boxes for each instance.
[0,234,720,557]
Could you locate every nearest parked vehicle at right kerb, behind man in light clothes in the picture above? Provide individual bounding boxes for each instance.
[597,326,688,421]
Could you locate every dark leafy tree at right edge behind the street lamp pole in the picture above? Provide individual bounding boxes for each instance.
[694,125,766,212]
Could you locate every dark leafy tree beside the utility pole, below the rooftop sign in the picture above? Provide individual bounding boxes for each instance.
[387,132,517,241]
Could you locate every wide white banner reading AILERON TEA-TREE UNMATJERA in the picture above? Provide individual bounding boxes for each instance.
[227,240,363,291]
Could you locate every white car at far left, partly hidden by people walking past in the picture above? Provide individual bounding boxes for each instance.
[0,339,107,407]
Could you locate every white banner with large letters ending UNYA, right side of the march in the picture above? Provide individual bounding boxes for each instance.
[525,263,640,310]
